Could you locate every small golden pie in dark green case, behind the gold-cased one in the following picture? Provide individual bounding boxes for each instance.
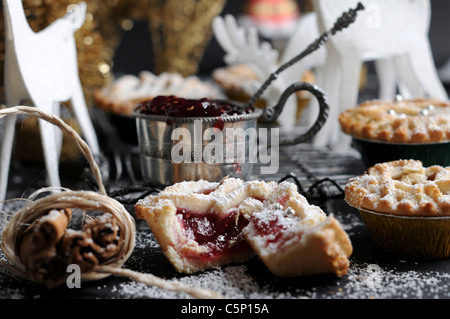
[339,98,450,167]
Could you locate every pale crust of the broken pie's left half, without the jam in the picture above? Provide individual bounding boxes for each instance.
[135,178,254,273]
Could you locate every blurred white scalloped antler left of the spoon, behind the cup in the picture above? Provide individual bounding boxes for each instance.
[212,15,279,81]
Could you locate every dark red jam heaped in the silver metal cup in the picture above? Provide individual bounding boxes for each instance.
[136,95,253,117]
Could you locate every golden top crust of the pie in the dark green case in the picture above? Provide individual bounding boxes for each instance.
[339,98,450,143]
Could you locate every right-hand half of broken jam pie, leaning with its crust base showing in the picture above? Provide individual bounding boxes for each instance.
[244,205,353,277]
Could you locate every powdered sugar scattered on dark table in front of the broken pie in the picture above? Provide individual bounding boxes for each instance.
[103,263,450,299]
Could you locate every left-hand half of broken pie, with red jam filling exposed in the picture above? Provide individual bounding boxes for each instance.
[136,178,261,273]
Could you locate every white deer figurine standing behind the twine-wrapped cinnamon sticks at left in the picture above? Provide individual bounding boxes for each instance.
[0,0,99,205]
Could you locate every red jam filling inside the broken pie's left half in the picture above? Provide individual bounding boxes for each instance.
[177,209,250,260]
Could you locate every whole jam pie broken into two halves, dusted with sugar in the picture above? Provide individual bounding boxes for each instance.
[135,178,352,276]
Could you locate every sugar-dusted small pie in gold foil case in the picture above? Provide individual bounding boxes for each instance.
[345,160,450,258]
